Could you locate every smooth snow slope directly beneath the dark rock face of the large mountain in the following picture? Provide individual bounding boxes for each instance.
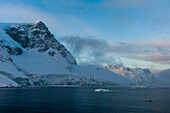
[12,49,71,74]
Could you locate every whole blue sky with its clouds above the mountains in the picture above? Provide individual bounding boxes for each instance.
[0,0,170,71]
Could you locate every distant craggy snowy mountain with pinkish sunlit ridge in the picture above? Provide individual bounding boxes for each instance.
[104,65,156,86]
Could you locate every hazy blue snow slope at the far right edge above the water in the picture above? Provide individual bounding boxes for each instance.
[157,69,170,87]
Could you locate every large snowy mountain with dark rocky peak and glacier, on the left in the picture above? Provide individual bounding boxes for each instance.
[0,21,132,87]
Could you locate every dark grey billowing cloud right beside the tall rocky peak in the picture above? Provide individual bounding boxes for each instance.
[60,36,123,65]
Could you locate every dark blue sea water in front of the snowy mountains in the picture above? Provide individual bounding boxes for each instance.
[0,87,170,113]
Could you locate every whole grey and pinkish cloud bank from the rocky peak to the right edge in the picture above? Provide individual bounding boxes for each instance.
[60,36,170,65]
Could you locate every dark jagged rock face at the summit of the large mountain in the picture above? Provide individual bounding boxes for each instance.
[5,21,77,64]
